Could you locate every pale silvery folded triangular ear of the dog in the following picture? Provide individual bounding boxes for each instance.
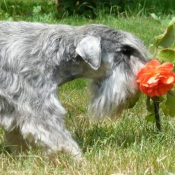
[76,36,101,70]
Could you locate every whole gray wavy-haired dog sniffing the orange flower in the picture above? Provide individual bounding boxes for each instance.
[0,22,148,158]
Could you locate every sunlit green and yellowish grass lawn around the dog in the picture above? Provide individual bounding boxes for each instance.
[0,1,175,175]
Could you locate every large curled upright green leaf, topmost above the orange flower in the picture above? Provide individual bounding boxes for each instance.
[156,22,174,48]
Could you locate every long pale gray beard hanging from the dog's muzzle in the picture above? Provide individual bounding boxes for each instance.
[89,59,144,119]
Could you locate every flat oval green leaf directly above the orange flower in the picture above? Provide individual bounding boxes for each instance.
[156,49,175,62]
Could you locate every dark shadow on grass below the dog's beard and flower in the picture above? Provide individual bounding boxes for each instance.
[71,117,175,152]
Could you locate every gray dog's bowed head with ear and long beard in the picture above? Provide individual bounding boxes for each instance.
[73,26,148,117]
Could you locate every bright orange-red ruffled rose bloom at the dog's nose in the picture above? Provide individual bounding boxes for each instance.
[137,60,175,97]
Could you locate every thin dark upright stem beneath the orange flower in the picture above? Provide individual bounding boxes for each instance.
[153,97,161,131]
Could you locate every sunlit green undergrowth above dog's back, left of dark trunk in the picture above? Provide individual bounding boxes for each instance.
[0,0,56,22]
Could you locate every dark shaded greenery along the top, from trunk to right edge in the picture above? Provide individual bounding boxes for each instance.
[56,0,175,18]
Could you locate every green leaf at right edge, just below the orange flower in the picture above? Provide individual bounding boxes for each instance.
[166,93,175,117]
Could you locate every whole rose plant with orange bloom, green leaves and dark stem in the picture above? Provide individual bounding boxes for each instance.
[139,14,175,131]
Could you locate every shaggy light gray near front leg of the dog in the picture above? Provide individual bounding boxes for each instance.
[15,98,81,159]
